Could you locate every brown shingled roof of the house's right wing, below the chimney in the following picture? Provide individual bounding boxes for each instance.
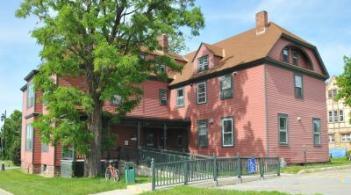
[171,22,324,85]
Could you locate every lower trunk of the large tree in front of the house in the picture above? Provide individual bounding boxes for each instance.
[84,100,102,177]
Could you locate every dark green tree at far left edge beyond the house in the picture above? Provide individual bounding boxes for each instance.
[0,110,22,165]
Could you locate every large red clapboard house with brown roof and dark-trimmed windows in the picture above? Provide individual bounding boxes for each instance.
[21,11,329,173]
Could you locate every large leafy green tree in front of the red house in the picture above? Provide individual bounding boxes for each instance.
[16,0,204,176]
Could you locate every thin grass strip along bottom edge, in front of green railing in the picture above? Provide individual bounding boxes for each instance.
[142,186,288,195]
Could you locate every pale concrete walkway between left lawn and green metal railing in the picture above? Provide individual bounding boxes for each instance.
[94,183,151,195]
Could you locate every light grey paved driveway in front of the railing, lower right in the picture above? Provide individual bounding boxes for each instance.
[220,169,351,195]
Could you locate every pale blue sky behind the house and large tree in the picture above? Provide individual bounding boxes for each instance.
[0,0,351,124]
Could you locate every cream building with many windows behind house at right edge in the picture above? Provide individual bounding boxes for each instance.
[326,76,351,150]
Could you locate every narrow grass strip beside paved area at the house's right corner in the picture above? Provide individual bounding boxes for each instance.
[281,158,351,173]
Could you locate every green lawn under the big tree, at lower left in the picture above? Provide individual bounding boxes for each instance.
[0,169,149,195]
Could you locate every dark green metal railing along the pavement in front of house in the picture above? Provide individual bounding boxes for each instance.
[151,157,280,190]
